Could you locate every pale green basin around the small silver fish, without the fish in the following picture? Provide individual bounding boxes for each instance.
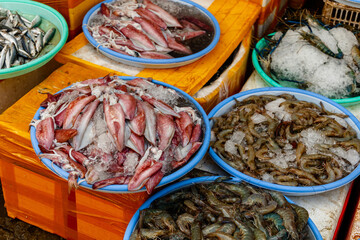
[0,0,69,79]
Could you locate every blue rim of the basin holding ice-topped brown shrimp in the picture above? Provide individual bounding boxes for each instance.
[208,87,360,196]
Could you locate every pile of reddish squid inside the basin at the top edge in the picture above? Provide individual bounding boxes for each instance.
[88,0,214,59]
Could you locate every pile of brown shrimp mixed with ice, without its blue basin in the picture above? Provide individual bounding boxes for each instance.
[211,94,360,186]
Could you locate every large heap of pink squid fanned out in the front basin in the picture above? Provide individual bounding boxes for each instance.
[31,76,203,194]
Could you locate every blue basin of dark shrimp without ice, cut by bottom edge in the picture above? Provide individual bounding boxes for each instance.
[124,177,322,240]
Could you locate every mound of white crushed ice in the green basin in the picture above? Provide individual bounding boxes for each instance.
[270,27,359,98]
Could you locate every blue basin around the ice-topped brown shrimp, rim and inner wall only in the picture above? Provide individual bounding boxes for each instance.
[208,87,360,196]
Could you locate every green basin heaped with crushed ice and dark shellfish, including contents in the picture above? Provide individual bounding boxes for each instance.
[252,11,360,106]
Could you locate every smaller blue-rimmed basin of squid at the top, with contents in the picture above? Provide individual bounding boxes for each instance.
[83,0,220,68]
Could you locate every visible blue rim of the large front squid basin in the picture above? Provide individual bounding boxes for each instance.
[30,76,210,193]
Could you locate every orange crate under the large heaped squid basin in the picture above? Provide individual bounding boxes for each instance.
[0,63,148,239]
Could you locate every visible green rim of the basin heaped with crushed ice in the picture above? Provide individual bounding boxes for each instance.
[251,33,360,106]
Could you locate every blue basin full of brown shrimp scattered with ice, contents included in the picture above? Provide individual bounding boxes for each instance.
[208,87,360,196]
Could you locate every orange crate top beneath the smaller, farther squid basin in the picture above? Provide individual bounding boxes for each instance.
[55,0,260,95]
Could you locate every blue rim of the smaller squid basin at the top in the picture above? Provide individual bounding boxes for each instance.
[82,0,220,66]
